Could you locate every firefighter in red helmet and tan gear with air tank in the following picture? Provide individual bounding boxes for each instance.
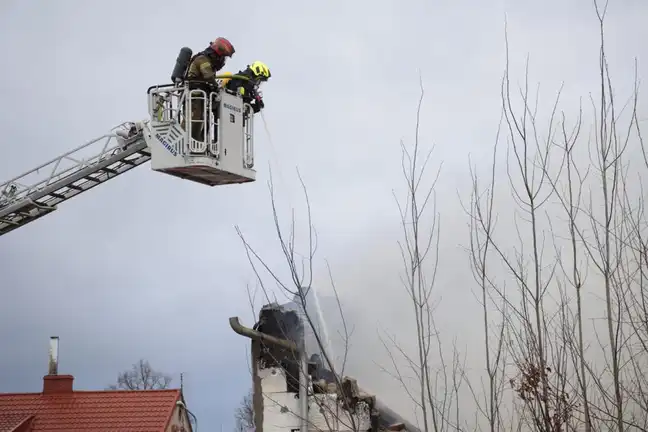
[186,37,236,141]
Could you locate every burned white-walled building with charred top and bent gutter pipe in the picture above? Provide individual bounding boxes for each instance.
[230,298,419,432]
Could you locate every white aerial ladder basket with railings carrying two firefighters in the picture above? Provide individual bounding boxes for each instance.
[143,77,256,186]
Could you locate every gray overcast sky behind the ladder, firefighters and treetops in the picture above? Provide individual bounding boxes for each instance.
[0,0,648,430]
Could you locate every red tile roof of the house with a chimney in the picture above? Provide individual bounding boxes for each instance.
[0,389,180,432]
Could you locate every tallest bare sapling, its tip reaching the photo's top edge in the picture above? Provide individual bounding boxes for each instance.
[536,0,636,432]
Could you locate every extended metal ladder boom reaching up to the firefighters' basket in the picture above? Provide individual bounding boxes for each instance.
[0,123,151,236]
